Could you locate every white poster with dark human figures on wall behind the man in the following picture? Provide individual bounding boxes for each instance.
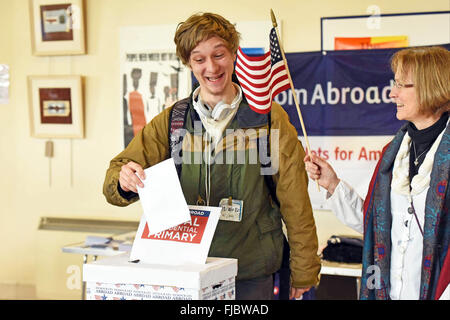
[120,25,191,147]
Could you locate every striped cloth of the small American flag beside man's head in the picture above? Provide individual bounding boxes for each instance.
[235,28,290,113]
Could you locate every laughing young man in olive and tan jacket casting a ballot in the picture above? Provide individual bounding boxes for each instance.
[104,13,320,299]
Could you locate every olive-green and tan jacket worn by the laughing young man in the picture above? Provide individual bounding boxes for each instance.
[103,97,320,287]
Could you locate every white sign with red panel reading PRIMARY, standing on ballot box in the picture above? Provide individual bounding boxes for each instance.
[130,206,222,265]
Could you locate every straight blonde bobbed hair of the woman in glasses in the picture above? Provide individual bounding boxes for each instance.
[391,47,450,114]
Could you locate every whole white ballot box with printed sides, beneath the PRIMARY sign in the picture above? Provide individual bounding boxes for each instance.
[83,253,237,300]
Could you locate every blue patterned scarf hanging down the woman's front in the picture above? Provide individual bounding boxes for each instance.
[360,125,450,300]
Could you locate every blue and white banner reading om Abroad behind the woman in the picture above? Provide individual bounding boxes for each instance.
[275,44,450,209]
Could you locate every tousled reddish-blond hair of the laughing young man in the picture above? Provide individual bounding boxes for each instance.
[173,12,240,66]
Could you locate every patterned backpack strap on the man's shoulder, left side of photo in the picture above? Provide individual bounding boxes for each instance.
[168,97,190,177]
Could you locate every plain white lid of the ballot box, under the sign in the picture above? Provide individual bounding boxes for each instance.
[83,253,238,289]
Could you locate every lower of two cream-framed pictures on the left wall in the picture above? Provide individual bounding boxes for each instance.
[28,75,84,138]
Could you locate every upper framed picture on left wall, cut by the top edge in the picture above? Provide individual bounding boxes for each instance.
[29,0,86,56]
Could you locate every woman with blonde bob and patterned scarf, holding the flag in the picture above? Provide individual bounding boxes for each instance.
[304,47,450,300]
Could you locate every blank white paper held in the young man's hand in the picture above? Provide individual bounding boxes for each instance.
[137,158,191,234]
